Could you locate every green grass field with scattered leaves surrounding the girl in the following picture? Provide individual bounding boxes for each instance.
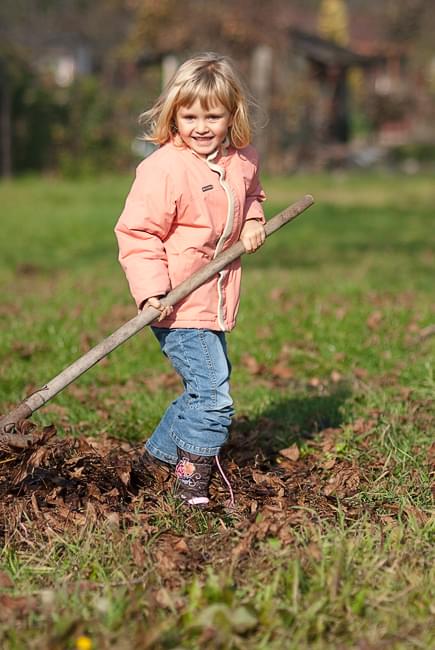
[0,173,435,650]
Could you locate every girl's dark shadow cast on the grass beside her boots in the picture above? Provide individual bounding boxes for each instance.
[226,385,352,465]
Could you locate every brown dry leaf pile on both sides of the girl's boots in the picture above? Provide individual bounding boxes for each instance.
[0,422,368,552]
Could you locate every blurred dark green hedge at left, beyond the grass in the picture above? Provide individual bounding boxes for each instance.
[7,51,159,176]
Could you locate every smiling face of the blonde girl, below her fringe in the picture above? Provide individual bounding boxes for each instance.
[175,99,232,158]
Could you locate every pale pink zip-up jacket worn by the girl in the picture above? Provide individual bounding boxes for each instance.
[115,143,265,331]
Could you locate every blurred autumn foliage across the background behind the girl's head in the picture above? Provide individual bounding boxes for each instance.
[0,0,435,174]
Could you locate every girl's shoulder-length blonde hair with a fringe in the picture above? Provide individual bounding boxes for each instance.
[139,52,252,148]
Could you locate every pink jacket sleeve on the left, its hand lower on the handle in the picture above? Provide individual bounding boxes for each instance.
[115,156,176,307]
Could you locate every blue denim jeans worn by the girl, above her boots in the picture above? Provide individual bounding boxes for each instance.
[145,327,234,464]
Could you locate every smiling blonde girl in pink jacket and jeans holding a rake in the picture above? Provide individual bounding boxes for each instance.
[115,53,265,507]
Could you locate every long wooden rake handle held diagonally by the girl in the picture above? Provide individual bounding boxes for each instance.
[0,194,314,447]
